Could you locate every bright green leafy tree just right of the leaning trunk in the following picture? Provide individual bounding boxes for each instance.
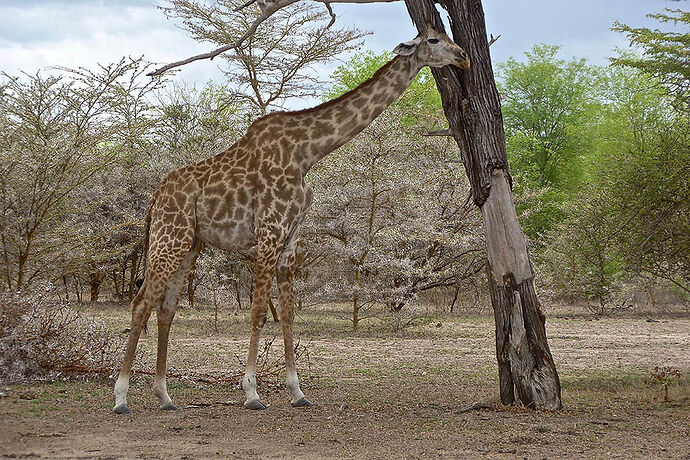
[498,45,593,190]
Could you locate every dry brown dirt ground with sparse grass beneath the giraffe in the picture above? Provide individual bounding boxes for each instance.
[0,308,690,459]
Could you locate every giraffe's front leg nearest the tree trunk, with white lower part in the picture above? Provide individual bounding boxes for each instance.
[277,252,312,407]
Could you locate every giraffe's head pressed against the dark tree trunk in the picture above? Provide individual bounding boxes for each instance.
[393,24,470,69]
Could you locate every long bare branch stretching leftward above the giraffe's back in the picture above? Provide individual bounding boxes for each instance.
[146,0,399,77]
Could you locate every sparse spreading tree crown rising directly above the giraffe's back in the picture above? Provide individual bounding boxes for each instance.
[161,0,365,116]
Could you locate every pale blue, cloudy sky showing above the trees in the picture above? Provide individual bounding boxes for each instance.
[0,0,674,105]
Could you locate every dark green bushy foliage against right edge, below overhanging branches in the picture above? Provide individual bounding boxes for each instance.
[599,117,690,292]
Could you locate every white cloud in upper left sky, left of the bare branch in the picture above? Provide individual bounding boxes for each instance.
[0,0,221,85]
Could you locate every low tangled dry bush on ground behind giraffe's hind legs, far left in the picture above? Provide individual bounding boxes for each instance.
[0,287,124,383]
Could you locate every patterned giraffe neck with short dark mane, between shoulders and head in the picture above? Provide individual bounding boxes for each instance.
[298,55,423,174]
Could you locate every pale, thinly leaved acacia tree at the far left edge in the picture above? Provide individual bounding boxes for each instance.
[0,59,159,289]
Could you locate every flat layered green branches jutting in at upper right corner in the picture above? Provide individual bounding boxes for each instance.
[611,8,690,110]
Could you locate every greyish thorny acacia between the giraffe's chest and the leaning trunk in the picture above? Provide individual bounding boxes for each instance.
[302,53,484,330]
